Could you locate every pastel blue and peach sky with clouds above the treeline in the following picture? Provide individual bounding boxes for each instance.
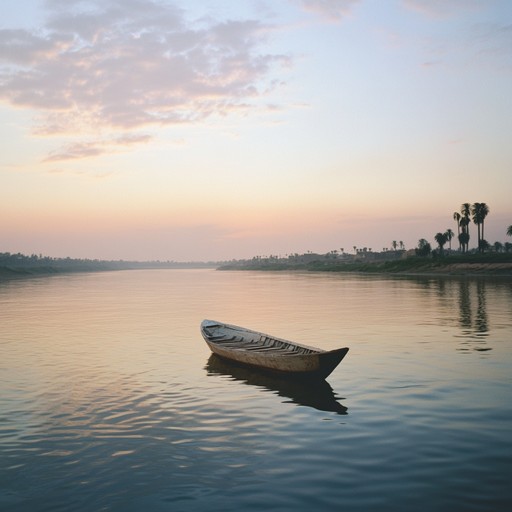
[0,0,512,261]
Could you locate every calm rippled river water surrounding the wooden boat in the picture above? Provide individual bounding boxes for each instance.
[0,270,512,512]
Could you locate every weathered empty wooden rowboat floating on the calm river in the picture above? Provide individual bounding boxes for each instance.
[201,320,348,379]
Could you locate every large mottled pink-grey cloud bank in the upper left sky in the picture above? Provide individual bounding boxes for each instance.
[0,0,290,159]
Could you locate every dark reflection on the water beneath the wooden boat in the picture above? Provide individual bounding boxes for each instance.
[205,354,347,414]
